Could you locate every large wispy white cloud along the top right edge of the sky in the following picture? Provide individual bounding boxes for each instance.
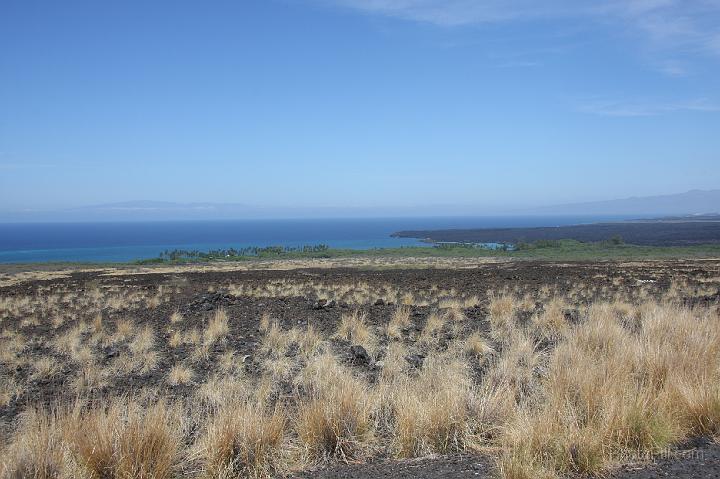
[319,0,720,58]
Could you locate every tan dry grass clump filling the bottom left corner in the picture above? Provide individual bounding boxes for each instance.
[0,401,181,479]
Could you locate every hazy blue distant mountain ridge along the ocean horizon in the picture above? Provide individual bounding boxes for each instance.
[0,189,720,222]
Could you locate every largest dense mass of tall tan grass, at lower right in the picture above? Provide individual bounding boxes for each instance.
[501,304,720,477]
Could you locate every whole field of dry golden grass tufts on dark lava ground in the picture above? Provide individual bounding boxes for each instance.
[0,261,720,479]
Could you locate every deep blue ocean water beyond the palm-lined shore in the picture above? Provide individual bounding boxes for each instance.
[0,216,622,263]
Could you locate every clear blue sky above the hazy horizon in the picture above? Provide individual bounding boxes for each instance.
[0,0,720,214]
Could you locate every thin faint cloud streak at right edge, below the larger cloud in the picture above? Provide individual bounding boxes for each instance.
[578,98,720,117]
